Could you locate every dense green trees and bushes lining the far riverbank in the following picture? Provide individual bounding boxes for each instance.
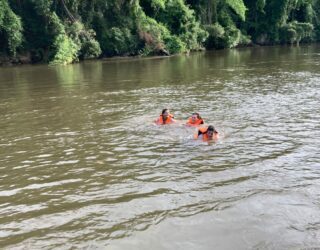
[0,0,320,64]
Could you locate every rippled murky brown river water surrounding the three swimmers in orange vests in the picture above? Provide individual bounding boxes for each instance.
[0,45,320,250]
